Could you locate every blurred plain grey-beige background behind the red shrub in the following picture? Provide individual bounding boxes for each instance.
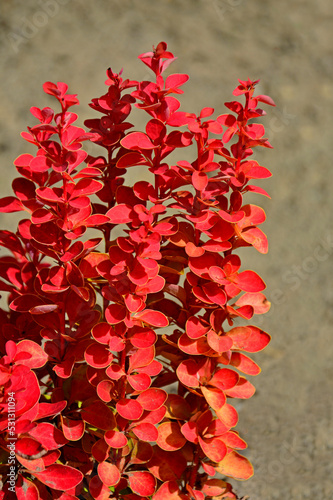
[0,0,333,500]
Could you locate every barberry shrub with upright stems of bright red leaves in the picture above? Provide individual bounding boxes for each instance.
[0,42,274,500]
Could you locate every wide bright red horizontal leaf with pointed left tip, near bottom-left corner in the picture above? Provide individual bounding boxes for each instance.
[33,464,83,491]
